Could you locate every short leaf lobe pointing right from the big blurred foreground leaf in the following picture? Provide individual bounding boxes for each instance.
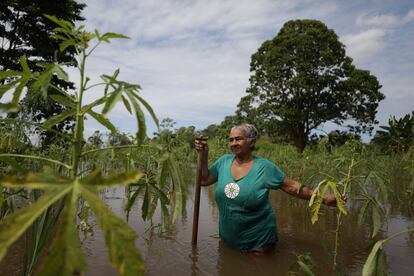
[81,170,143,189]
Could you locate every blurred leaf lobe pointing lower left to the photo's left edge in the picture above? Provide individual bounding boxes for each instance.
[0,186,71,261]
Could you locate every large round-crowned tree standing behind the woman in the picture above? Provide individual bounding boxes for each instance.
[236,20,384,151]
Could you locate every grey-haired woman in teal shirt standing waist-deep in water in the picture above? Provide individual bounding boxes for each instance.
[195,124,336,254]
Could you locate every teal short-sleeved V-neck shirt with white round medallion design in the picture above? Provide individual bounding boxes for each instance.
[209,154,285,251]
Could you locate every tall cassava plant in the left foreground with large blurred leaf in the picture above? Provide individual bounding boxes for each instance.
[0,15,158,275]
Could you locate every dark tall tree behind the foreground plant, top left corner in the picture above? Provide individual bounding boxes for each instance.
[0,0,86,144]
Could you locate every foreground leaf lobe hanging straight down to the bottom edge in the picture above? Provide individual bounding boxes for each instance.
[37,181,86,276]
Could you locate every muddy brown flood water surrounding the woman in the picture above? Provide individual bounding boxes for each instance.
[81,186,414,275]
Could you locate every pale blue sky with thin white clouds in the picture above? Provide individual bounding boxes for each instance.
[75,0,414,138]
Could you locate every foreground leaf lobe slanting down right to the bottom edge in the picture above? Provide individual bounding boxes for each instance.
[80,185,144,276]
